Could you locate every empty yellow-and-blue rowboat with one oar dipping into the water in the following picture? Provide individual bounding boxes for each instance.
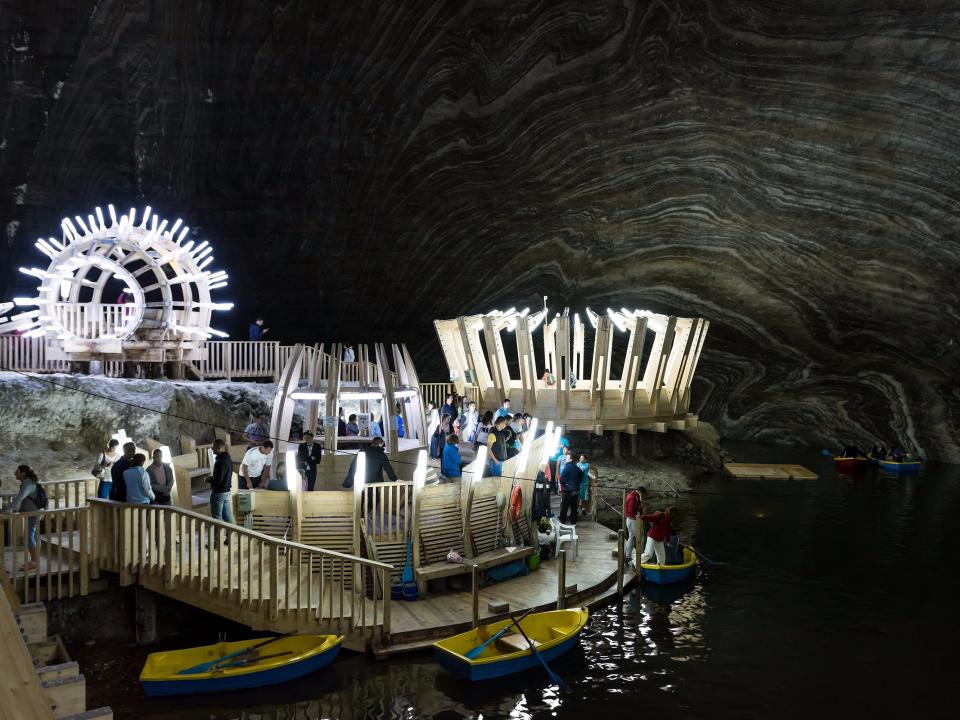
[433,608,590,680]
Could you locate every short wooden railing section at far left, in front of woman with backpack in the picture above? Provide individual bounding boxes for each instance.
[0,507,90,603]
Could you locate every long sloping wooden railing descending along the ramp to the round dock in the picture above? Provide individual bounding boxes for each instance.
[91,500,393,644]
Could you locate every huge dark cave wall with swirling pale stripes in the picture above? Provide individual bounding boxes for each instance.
[0,0,960,462]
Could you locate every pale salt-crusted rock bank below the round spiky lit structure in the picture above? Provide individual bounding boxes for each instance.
[0,372,302,489]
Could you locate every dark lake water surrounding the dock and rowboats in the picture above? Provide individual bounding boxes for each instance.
[80,445,960,720]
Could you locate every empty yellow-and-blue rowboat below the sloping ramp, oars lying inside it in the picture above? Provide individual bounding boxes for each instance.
[140,635,343,697]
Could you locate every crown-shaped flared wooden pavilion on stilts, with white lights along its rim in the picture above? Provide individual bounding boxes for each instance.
[434,303,710,434]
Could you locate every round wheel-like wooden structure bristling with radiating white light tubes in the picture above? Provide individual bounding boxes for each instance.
[0,205,233,361]
